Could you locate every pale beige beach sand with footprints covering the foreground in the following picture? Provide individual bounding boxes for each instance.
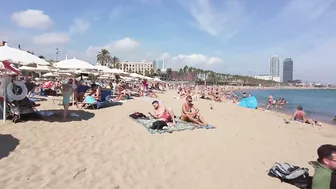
[0,91,336,189]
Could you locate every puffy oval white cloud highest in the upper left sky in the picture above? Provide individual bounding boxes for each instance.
[11,9,53,30]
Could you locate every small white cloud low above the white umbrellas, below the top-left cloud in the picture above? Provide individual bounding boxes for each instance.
[33,32,70,45]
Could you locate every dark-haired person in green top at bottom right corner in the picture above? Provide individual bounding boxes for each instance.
[312,144,336,189]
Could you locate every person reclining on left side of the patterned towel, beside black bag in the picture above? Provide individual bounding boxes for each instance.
[148,100,176,126]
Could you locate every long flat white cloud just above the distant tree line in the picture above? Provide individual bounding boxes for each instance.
[172,54,223,65]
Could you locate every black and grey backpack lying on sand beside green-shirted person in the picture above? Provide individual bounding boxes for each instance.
[268,163,312,189]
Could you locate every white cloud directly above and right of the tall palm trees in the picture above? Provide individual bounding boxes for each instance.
[87,37,140,53]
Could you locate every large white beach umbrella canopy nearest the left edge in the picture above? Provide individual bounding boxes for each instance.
[0,45,49,65]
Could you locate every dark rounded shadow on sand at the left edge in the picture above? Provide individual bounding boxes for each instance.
[0,134,20,160]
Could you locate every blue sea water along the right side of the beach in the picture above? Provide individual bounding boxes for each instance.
[240,89,336,123]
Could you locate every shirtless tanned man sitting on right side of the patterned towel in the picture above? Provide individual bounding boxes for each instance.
[181,96,208,126]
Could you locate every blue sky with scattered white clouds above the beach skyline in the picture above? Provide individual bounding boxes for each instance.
[0,0,336,82]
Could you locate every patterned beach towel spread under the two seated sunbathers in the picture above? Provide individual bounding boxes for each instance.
[133,119,215,134]
